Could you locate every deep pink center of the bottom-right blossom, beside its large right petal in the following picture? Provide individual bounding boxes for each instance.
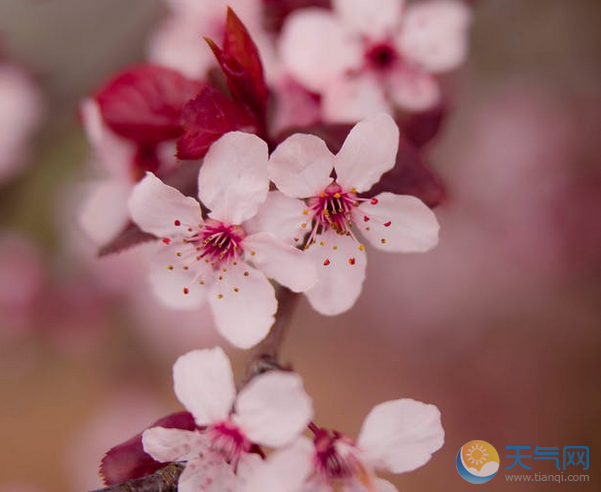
[314,429,363,480]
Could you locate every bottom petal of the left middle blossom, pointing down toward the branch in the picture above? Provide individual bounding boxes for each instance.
[209,262,278,349]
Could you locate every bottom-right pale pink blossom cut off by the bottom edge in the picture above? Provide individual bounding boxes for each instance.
[242,399,444,492]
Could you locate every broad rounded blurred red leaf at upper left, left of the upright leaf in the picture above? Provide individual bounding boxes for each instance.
[96,65,206,146]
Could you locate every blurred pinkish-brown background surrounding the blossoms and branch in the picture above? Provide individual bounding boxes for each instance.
[0,0,601,492]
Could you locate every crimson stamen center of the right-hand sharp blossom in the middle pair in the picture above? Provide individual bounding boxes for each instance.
[307,182,359,236]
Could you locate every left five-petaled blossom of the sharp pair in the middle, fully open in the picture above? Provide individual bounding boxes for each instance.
[129,132,317,348]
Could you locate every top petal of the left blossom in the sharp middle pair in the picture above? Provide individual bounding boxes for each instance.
[198,132,269,224]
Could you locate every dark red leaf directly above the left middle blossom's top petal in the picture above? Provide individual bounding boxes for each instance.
[177,87,257,159]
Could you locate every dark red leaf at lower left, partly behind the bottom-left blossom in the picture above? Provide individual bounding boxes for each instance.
[100,412,197,485]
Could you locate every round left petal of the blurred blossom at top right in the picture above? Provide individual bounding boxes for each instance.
[280,8,363,92]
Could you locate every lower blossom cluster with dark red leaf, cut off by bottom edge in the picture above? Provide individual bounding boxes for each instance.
[101,348,444,492]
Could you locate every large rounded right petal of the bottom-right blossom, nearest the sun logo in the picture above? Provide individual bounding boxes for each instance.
[357,399,444,473]
